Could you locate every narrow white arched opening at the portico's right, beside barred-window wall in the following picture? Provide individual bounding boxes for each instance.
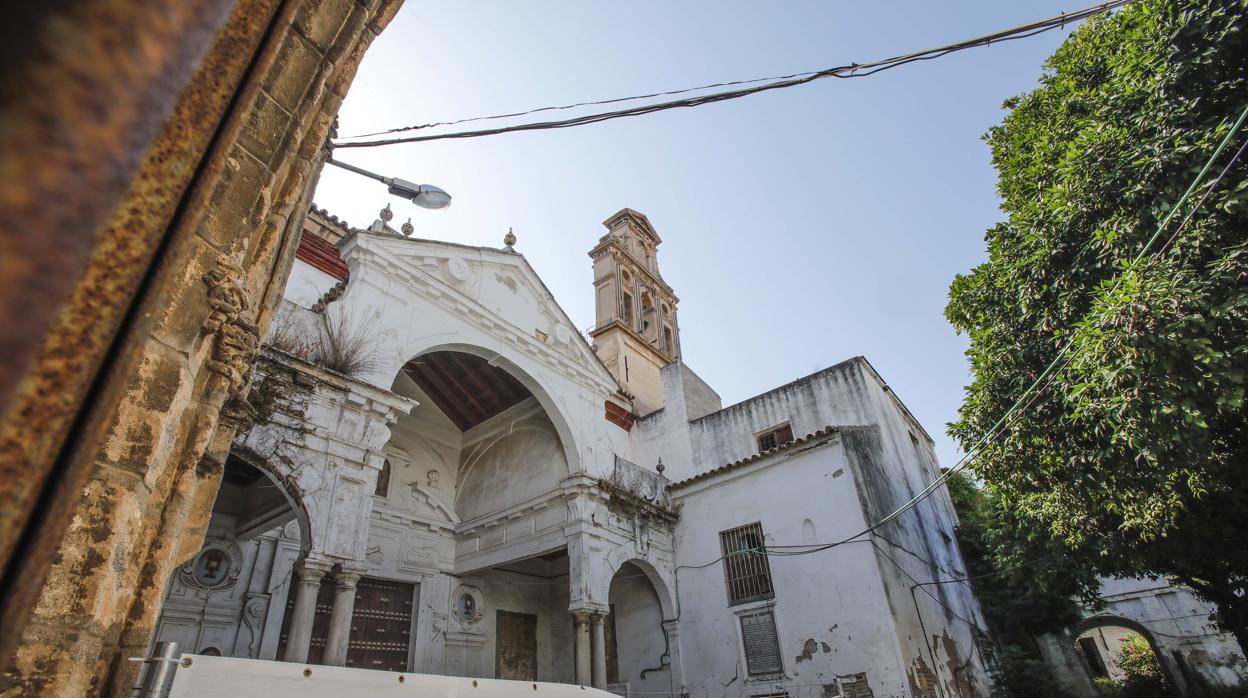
[605,561,673,693]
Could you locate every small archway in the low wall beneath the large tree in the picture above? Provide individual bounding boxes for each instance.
[1075,616,1187,696]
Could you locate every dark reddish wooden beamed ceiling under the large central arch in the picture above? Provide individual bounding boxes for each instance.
[404,351,533,431]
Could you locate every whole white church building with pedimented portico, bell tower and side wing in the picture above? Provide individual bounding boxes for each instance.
[156,209,991,698]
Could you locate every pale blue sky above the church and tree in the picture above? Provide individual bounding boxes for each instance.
[314,0,1082,466]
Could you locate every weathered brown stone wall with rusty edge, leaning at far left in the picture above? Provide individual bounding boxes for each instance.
[0,0,399,697]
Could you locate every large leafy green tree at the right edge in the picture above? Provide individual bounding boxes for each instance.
[946,0,1248,651]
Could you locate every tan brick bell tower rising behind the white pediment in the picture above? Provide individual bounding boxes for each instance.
[589,209,680,416]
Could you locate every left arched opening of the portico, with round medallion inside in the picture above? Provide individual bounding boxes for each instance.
[154,453,311,659]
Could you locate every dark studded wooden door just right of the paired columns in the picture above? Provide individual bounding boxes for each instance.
[347,577,416,672]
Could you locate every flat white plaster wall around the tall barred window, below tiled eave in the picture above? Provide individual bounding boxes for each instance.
[675,440,909,696]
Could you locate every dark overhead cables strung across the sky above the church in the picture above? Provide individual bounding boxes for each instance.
[333,0,1134,147]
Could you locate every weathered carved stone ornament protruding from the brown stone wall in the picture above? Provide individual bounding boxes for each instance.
[203,255,260,396]
